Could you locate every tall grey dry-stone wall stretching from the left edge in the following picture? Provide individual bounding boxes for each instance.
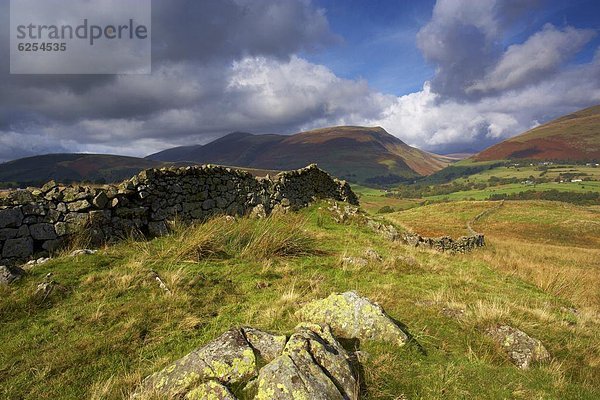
[0,164,358,265]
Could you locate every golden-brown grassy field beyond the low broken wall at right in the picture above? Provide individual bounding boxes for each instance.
[386,201,600,313]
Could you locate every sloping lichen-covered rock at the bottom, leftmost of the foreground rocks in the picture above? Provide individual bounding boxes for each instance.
[138,329,257,396]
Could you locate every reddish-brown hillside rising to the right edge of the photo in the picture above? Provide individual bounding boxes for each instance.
[474,105,600,161]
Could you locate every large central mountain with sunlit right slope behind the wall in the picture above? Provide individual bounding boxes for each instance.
[147,126,452,184]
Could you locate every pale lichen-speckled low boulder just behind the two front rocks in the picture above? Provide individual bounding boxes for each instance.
[297,292,408,346]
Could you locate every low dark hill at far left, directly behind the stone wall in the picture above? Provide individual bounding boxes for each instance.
[0,154,164,186]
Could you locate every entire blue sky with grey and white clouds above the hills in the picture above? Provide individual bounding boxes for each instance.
[0,0,600,162]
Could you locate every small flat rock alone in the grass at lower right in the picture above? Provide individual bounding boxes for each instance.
[487,325,550,369]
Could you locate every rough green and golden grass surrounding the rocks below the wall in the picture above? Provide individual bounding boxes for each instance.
[0,202,600,399]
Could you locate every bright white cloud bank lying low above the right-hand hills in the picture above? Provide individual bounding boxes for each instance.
[363,50,600,151]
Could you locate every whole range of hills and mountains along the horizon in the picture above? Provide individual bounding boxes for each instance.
[0,105,600,186]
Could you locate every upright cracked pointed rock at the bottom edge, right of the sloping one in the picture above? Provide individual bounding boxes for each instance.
[255,325,357,400]
